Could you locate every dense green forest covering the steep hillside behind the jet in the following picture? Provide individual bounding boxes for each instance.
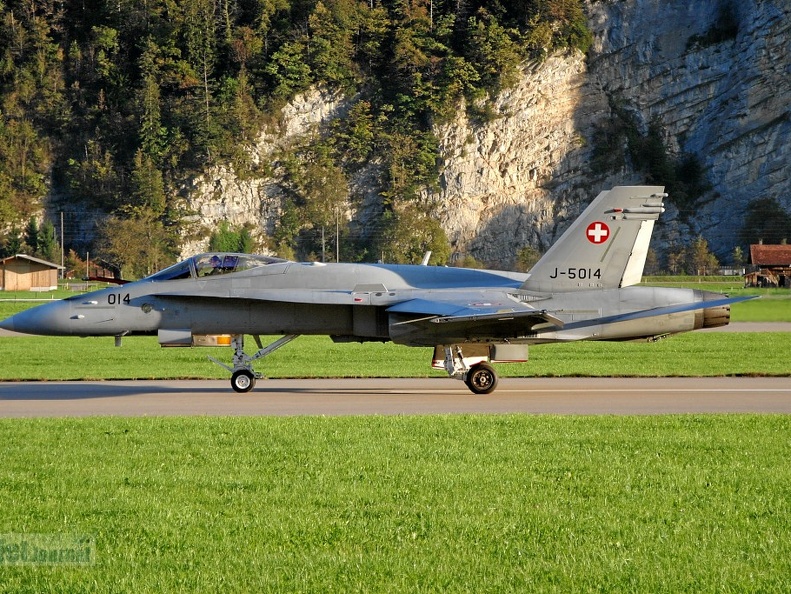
[0,0,590,276]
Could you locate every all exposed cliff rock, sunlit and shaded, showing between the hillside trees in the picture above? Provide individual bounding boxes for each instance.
[184,0,791,267]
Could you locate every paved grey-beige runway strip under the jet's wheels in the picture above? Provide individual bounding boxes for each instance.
[0,377,791,417]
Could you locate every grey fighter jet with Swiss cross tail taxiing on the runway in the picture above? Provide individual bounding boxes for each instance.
[0,186,743,394]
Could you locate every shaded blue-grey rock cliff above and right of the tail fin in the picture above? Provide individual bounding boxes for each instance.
[587,0,791,257]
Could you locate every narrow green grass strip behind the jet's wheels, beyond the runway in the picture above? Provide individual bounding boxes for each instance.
[0,332,791,380]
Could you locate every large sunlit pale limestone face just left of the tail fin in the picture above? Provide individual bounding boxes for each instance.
[431,54,606,266]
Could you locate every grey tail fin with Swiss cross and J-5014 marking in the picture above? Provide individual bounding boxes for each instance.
[522,186,667,292]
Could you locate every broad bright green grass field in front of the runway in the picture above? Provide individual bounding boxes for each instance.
[0,415,791,592]
